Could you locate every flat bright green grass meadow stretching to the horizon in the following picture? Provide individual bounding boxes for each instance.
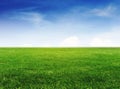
[0,48,120,89]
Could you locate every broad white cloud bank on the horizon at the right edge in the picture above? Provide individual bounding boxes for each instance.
[90,27,120,47]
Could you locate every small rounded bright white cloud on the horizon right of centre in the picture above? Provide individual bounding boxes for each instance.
[60,36,80,47]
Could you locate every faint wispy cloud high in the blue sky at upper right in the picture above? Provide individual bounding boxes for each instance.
[90,5,116,17]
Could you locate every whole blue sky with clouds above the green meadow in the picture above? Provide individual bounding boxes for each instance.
[0,0,120,47]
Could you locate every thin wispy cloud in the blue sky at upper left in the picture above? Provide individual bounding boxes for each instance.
[9,12,45,25]
